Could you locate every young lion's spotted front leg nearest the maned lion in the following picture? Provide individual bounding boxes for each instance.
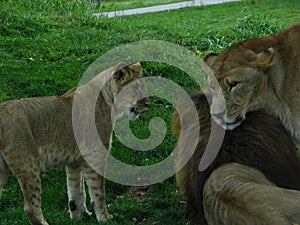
[84,165,113,222]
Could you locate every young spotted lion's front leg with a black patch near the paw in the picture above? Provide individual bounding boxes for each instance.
[66,166,91,219]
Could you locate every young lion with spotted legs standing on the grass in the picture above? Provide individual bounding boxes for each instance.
[0,63,149,225]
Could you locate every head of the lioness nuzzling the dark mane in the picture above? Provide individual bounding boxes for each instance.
[203,43,274,130]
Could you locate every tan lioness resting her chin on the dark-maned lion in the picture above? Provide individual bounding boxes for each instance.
[203,25,300,146]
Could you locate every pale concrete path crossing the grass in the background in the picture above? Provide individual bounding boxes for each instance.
[94,0,240,18]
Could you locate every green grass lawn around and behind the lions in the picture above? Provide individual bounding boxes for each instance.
[0,0,300,225]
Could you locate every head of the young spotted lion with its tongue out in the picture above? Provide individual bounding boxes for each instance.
[113,62,150,120]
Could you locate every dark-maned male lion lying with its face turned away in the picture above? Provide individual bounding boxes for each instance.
[173,94,300,225]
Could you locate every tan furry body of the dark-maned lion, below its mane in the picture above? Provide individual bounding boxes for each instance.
[203,163,300,225]
